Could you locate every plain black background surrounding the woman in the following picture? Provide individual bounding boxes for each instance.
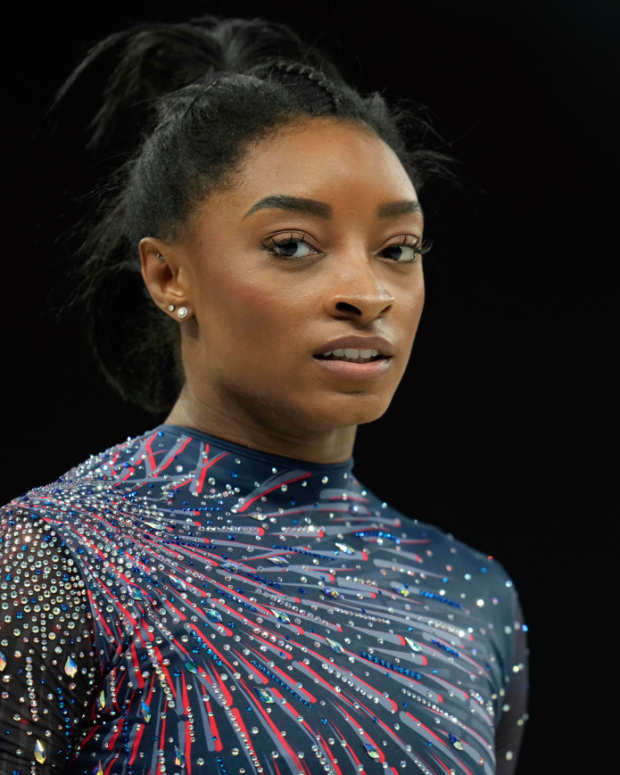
[1,0,620,775]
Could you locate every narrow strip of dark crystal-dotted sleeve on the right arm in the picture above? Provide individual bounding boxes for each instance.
[495,588,529,775]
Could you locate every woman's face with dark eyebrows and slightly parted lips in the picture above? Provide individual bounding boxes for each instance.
[153,118,424,448]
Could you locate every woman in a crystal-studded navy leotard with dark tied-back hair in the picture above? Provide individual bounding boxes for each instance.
[0,16,527,775]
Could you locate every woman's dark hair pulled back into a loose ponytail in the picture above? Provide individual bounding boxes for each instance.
[52,14,456,414]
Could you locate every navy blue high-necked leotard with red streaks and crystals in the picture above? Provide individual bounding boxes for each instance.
[0,424,528,775]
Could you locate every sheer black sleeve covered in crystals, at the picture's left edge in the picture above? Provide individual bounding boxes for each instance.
[0,506,97,775]
